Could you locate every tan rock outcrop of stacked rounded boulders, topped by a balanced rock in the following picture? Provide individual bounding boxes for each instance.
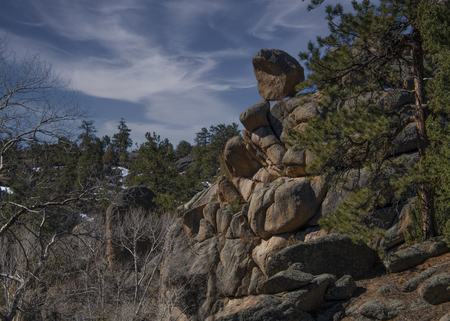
[171,50,447,320]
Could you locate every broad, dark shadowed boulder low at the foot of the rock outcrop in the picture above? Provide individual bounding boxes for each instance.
[267,234,379,279]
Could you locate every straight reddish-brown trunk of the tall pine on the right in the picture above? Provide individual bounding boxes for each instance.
[411,26,437,240]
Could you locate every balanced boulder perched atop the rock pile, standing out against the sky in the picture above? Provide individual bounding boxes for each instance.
[252,49,305,100]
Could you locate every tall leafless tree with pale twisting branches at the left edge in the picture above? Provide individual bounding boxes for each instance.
[0,39,107,320]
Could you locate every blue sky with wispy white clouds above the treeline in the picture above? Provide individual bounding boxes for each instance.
[0,0,336,146]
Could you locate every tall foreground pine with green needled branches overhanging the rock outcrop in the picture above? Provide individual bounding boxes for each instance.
[291,0,449,239]
